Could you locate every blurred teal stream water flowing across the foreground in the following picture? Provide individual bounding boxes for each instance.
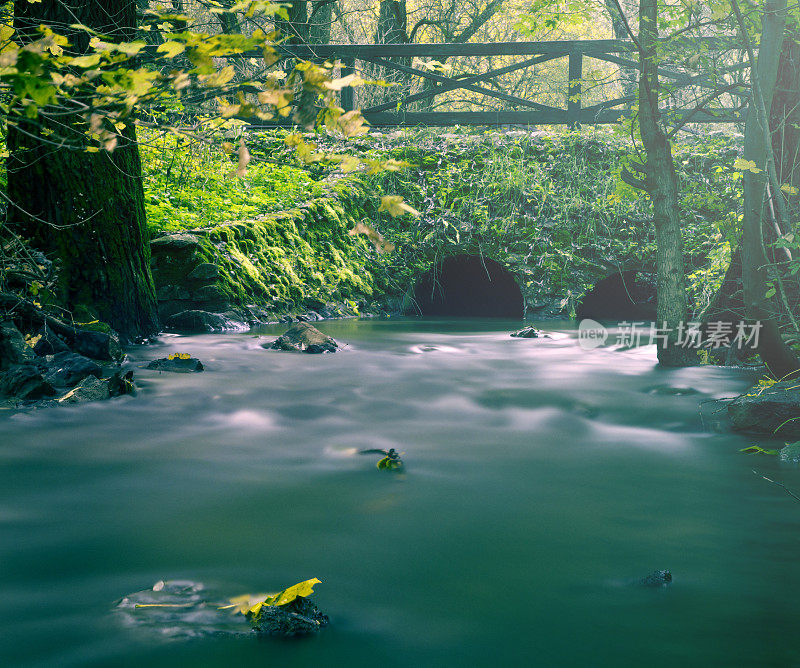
[0,319,800,668]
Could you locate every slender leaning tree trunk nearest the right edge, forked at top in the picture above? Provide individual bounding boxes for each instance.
[732,0,800,378]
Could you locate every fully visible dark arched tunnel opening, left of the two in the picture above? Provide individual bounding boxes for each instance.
[414,255,525,319]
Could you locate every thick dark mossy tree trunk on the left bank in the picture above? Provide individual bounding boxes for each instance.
[7,0,158,340]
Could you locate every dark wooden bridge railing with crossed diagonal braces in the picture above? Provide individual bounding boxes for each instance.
[230,38,749,126]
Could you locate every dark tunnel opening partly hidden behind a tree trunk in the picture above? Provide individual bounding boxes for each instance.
[577,271,656,322]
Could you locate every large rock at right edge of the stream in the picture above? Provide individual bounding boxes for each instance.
[728,381,800,438]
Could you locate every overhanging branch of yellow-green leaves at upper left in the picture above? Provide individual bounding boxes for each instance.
[0,1,418,215]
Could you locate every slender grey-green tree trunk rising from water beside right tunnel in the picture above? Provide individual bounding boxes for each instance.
[639,0,697,366]
